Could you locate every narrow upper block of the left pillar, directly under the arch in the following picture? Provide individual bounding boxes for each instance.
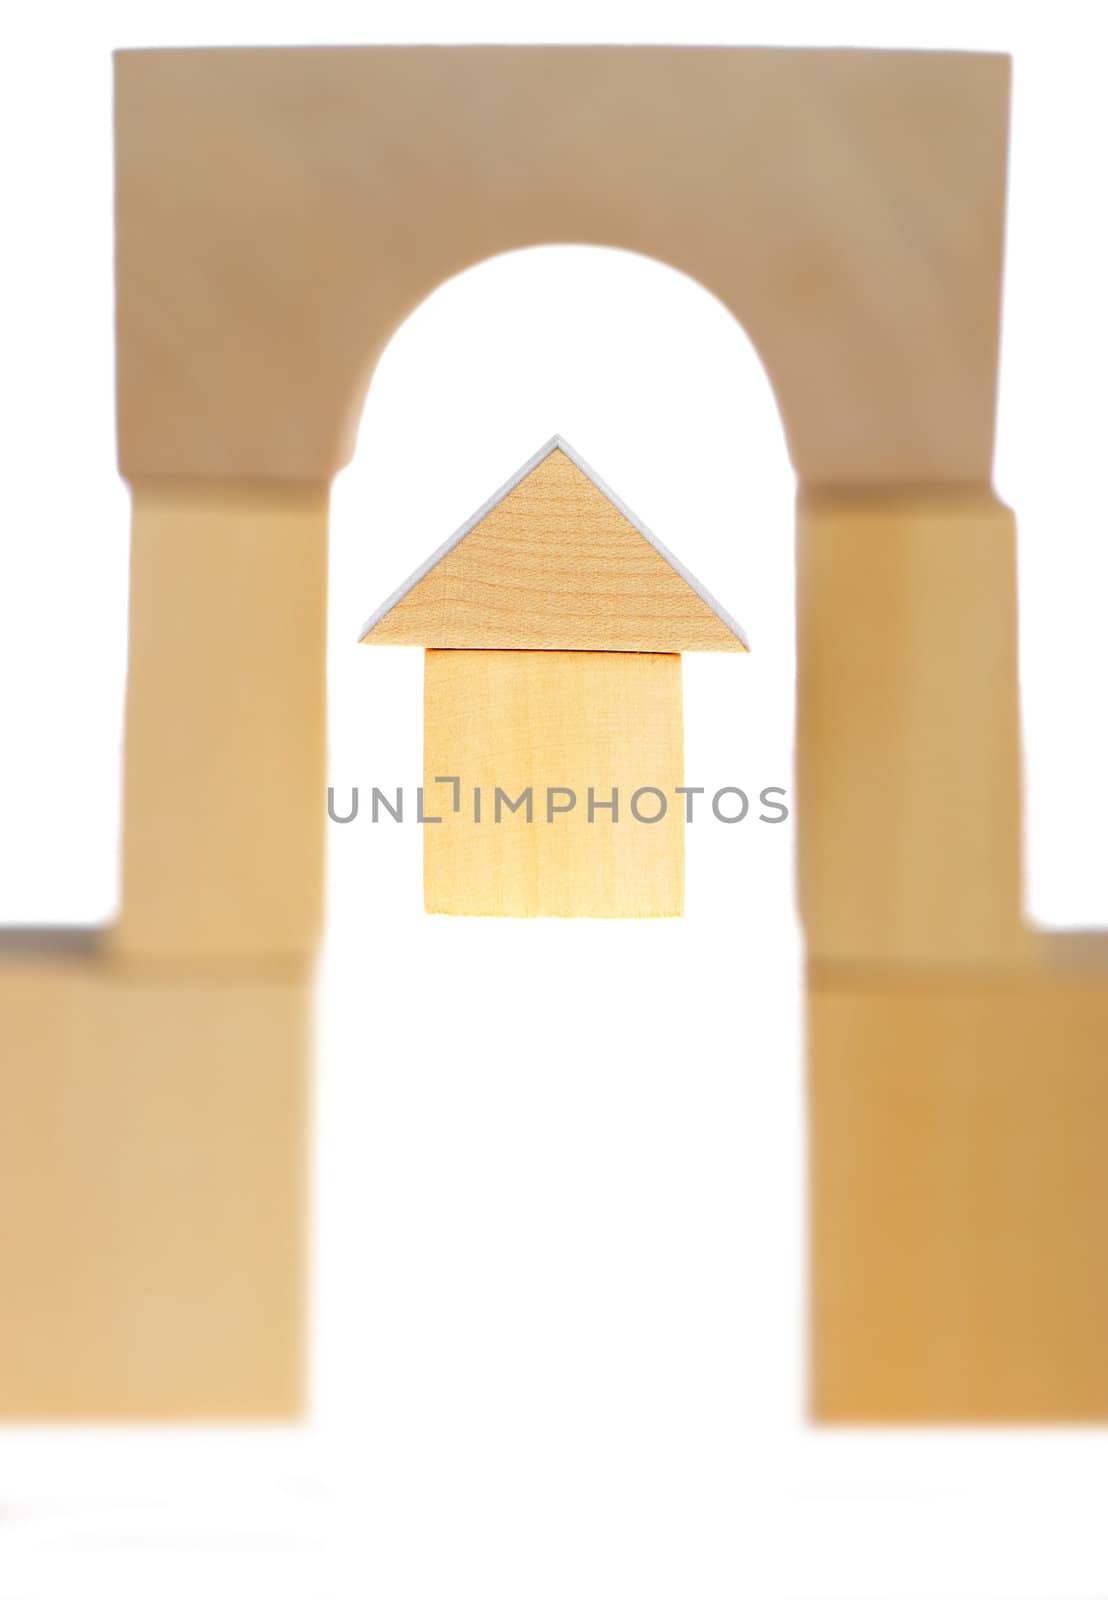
[114,485,327,958]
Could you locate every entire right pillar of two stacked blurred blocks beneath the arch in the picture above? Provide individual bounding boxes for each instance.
[797,488,1108,1422]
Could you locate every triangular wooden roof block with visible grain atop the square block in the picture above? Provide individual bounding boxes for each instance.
[362,435,749,653]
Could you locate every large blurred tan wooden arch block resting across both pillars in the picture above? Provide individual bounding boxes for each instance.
[115,46,1009,483]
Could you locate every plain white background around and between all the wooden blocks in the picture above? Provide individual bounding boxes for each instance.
[0,3,1108,1600]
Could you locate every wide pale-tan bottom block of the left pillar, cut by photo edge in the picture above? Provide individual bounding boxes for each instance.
[0,957,309,1419]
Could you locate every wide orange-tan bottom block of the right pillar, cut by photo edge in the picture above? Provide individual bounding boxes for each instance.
[809,940,1108,1422]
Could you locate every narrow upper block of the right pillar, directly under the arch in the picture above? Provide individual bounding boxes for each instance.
[796,490,1026,966]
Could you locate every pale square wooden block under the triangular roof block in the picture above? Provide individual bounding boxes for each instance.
[423,650,685,917]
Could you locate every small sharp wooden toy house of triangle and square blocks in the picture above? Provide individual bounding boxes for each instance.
[362,437,748,917]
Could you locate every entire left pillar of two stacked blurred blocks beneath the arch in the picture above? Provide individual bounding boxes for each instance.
[0,483,328,1418]
